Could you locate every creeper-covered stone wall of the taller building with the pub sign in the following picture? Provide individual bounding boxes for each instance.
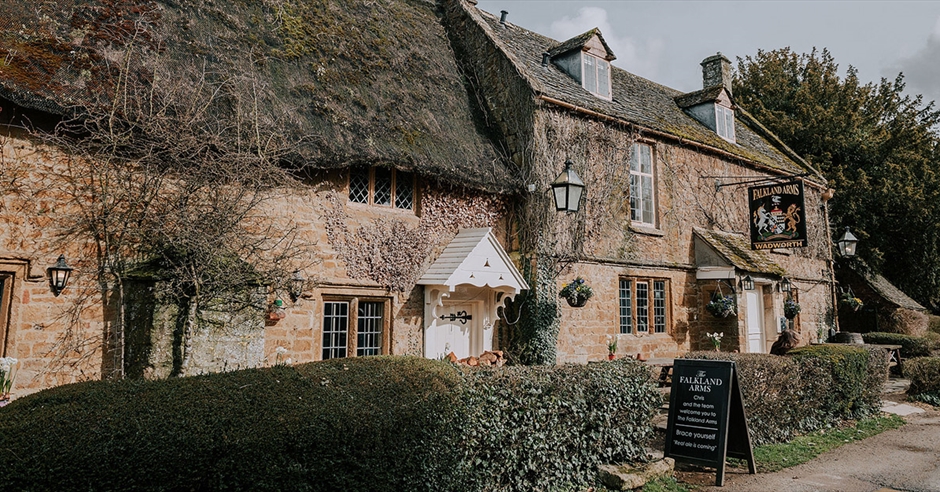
[535,107,833,362]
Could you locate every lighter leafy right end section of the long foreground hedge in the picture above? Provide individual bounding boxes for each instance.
[460,359,663,491]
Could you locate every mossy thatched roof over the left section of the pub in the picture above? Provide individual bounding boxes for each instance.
[0,0,519,192]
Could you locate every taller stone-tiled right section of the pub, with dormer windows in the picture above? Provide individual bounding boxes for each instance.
[445,0,835,362]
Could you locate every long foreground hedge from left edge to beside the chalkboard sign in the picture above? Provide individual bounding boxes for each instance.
[0,357,660,491]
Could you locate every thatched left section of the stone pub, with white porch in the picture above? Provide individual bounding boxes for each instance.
[0,0,528,395]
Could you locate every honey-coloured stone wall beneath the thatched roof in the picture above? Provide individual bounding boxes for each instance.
[0,128,512,396]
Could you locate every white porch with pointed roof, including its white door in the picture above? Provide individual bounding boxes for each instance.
[418,228,529,359]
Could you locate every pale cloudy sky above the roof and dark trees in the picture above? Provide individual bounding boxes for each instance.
[477,0,940,105]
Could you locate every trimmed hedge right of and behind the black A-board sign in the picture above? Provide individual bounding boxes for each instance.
[686,344,888,446]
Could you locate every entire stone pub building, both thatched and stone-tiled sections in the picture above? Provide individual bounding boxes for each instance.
[0,0,835,394]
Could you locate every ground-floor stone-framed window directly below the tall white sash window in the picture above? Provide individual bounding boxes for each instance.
[620,278,668,334]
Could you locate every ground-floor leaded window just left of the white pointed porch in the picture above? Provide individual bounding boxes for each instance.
[322,298,388,360]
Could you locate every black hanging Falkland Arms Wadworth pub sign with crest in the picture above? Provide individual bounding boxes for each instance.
[747,181,807,249]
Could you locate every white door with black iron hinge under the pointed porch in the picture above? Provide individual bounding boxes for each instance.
[424,302,484,359]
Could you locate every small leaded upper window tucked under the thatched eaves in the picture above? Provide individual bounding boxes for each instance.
[349,167,415,210]
